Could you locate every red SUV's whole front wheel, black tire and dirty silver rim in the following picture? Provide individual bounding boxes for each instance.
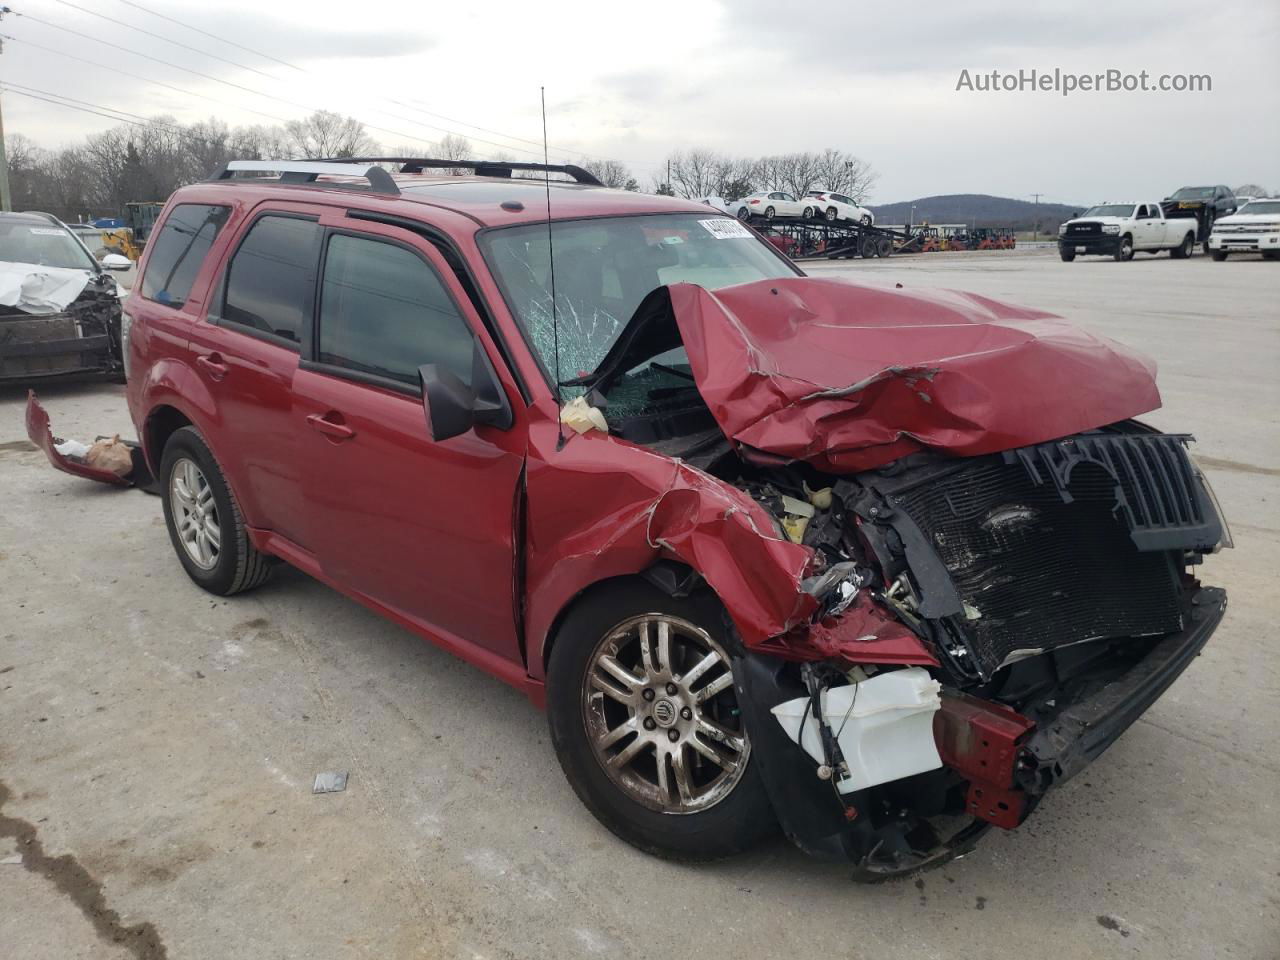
[547,580,777,860]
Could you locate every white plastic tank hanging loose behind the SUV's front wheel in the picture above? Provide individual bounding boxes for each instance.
[773,667,942,794]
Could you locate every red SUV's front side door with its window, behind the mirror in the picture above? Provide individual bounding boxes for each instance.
[293,218,524,660]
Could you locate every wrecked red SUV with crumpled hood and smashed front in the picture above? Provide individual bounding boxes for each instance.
[104,157,1226,877]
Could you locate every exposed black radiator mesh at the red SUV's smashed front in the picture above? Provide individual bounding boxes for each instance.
[895,457,1181,675]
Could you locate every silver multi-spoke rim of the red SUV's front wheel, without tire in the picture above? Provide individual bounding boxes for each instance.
[582,613,751,814]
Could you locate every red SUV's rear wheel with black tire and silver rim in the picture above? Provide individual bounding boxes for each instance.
[160,426,271,596]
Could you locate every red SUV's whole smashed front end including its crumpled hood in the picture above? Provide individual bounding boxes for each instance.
[572,272,1229,879]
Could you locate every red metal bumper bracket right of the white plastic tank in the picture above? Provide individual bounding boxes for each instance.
[933,694,1036,829]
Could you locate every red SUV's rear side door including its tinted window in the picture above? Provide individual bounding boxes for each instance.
[191,202,324,549]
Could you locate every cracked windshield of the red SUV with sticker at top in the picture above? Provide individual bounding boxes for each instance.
[481,214,799,403]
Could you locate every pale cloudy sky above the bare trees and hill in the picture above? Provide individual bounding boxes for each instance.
[0,0,1280,204]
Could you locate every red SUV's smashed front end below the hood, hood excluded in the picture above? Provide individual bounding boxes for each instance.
[721,430,1226,878]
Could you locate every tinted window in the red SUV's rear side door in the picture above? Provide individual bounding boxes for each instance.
[221,216,320,343]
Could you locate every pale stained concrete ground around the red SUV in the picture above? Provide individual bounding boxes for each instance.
[0,252,1280,960]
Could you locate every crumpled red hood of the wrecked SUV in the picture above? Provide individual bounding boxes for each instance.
[660,276,1160,472]
